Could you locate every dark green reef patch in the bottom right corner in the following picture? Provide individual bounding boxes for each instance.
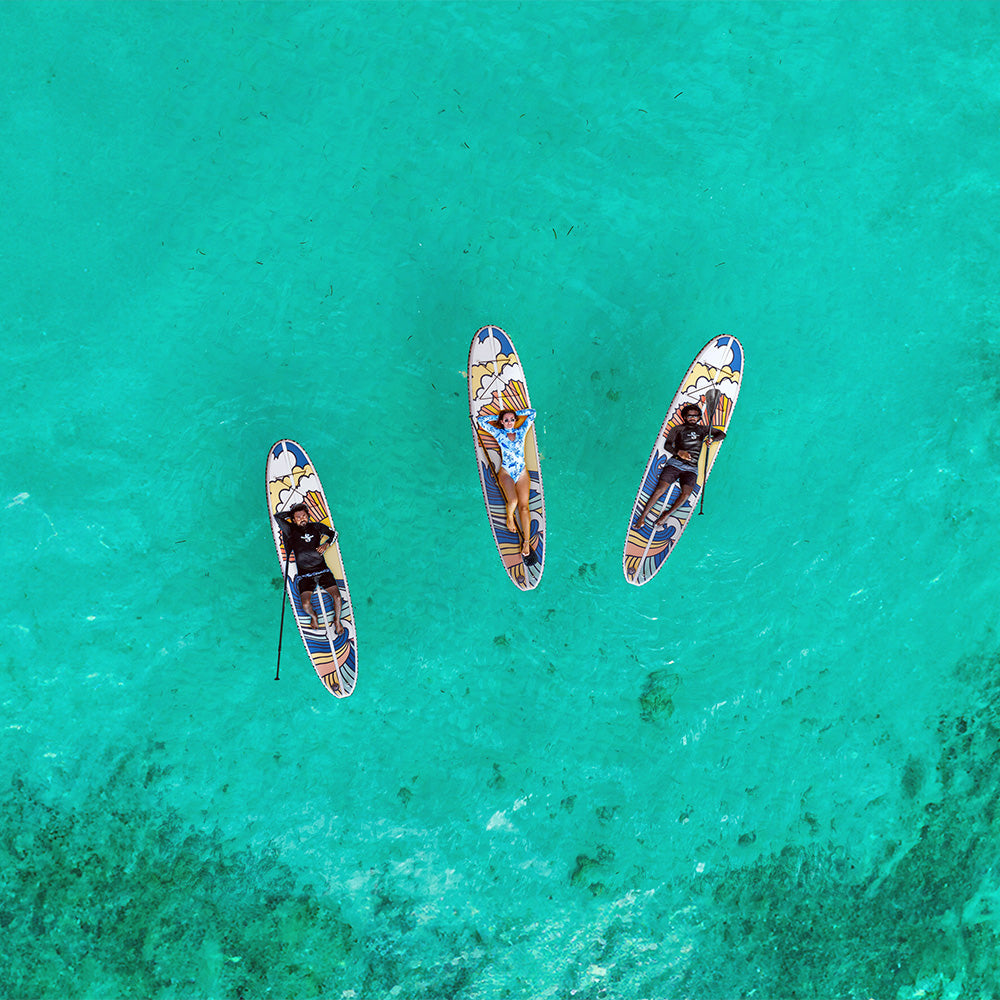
[672,640,1000,1000]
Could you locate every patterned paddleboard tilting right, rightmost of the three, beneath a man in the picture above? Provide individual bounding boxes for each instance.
[622,335,744,587]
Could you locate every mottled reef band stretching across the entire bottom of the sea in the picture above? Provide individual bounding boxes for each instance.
[0,653,1000,1000]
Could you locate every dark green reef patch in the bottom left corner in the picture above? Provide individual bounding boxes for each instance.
[0,750,355,997]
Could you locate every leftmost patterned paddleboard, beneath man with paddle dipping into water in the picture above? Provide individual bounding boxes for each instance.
[267,439,358,698]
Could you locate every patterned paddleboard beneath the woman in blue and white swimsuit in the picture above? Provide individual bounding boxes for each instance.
[469,326,545,590]
